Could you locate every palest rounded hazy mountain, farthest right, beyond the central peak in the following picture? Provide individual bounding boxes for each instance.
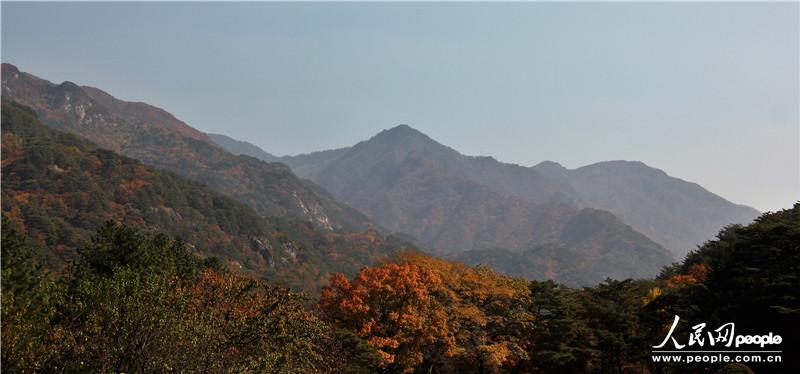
[533,161,759,258]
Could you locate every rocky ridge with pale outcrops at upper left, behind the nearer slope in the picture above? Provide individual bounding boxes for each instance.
[2,64,374,234]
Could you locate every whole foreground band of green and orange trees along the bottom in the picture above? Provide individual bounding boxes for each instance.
[2,204,800,373]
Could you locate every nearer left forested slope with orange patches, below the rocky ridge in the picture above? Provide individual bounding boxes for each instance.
[2,100,407,292]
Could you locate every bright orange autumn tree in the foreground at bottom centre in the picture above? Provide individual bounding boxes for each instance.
[318,252,532,372]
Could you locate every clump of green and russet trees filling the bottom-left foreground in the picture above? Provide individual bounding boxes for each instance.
[2,222,330,373]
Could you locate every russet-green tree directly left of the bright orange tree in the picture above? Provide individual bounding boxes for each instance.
[172,269,328,373]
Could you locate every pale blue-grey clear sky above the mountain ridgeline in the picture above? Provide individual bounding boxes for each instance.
[2,1,800,211]
